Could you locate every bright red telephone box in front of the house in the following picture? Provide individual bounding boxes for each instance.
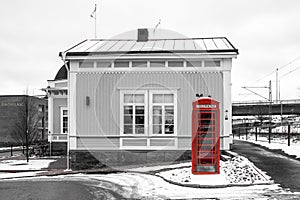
[192,97,220,174]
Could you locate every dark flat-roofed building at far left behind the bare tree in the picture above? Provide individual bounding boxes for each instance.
[0,95,48,145]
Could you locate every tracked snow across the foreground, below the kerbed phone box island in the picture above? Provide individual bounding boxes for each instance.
[62,172,300,200]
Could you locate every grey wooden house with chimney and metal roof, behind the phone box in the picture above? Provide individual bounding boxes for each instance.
[47,30,238,168]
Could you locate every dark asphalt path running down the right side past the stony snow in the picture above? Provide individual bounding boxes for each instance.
[232,140,300,192]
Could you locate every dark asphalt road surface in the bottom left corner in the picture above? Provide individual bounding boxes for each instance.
[0,179,123,200]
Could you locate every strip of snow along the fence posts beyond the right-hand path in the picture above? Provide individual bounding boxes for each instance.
[237,136,300,158]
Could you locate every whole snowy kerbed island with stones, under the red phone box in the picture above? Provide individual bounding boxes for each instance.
[156,156,271,186]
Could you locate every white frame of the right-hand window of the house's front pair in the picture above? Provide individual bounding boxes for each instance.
[149,90,177,137]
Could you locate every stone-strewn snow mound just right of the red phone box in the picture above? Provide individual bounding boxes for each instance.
[222,156,271,184]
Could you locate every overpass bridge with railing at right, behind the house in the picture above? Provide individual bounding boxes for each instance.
[232,99,300,116]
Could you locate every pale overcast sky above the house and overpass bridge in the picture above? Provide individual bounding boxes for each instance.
[0,0,300,101]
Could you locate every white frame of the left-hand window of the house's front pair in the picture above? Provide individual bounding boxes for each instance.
[120,90,149,137]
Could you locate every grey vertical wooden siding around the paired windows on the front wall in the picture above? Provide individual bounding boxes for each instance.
[76,72,223,138]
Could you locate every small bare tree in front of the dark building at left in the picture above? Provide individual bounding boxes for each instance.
[12,96,42,162]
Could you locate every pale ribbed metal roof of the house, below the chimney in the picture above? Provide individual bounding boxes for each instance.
[60,37,238,56]
